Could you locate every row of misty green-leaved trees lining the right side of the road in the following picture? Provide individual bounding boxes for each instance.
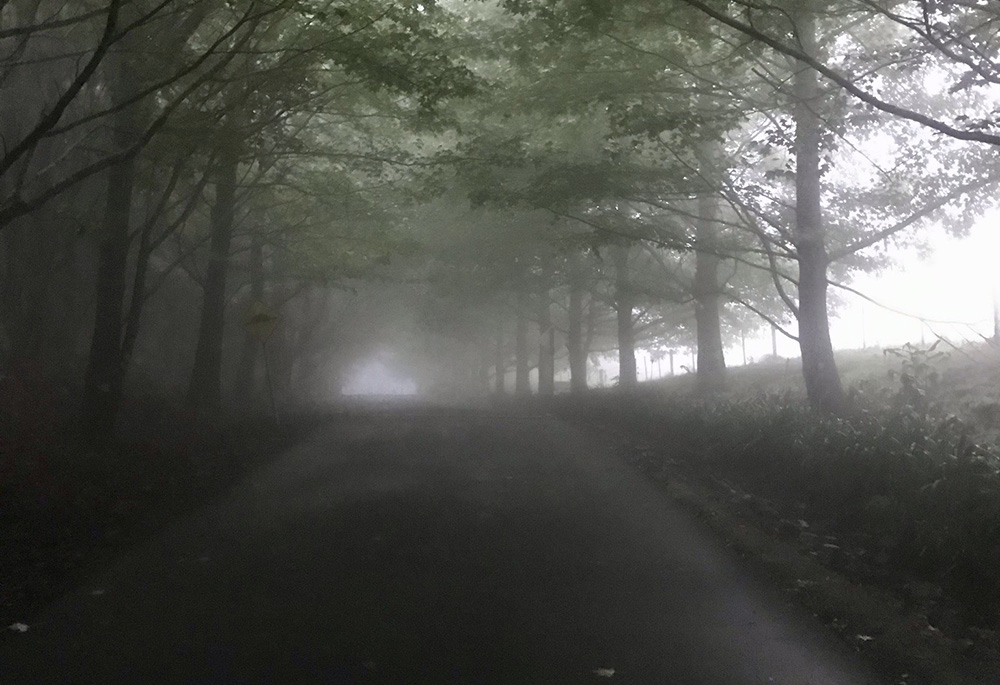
[402,0,997,412]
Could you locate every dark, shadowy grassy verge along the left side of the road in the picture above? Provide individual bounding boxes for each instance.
[0,402,318,639]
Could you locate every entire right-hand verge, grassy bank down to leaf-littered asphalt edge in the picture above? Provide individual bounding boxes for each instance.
[559,349,1000,683]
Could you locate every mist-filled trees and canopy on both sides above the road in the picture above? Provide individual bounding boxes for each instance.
[0,0,1000,440]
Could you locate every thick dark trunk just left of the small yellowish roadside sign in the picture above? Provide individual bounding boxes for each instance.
[187,146,239,415]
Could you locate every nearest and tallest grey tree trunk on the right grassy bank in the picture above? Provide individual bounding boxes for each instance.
[794,0,844,413]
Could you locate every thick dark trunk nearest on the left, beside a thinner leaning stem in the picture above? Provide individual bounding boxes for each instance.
[81,126,136,440]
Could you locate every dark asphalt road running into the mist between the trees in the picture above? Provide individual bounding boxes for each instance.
[0,409,876,685]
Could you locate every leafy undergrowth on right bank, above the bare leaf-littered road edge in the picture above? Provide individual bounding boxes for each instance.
[563,347,1000,628]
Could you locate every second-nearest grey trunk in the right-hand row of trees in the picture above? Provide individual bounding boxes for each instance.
[694,195,726,393]
